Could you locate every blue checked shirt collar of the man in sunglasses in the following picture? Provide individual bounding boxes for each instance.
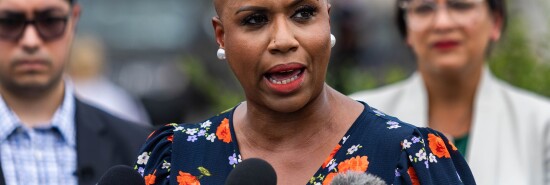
[0,79,76,147]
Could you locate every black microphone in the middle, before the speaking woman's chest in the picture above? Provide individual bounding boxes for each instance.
[225,158,277,185]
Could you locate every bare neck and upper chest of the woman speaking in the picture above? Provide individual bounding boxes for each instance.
[234,85,363,151]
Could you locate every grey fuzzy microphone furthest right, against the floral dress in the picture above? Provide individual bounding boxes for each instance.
[330,171,387,185]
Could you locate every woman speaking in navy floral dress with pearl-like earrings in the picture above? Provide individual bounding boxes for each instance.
[135,0,475,185]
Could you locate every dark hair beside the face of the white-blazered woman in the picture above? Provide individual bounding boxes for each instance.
[395,0,508,38]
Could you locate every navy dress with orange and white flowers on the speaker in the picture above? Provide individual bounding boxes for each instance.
[134,103,475,185]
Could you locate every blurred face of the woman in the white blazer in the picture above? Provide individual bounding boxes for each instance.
[405,0,502,74]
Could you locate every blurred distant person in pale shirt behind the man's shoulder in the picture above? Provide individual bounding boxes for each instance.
[68,35,150,125]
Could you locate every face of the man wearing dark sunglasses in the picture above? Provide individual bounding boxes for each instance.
[0,0,80,92]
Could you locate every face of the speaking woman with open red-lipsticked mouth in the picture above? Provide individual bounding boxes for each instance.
[213,0,330,112]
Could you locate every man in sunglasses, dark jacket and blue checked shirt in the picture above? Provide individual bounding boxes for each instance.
[0,0,148,185]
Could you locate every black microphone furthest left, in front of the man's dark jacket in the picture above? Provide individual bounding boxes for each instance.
[97,165,145,185]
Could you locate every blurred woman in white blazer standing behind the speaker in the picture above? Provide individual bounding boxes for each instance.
[352,0,550,185]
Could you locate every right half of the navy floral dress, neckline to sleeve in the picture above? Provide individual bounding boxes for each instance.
[323,104,475,185]
